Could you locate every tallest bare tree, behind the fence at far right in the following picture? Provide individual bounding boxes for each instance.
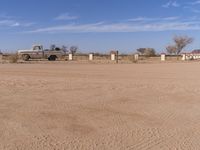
[166,36,193,55]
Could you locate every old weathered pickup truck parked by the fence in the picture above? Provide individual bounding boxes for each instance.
[17,45,66,61]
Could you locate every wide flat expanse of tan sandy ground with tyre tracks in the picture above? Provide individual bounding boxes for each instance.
[0,63,200,150]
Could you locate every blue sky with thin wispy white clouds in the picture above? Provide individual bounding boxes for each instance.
[0,0,200,53]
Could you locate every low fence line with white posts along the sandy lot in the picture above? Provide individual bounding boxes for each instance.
[0,53,200,63]
